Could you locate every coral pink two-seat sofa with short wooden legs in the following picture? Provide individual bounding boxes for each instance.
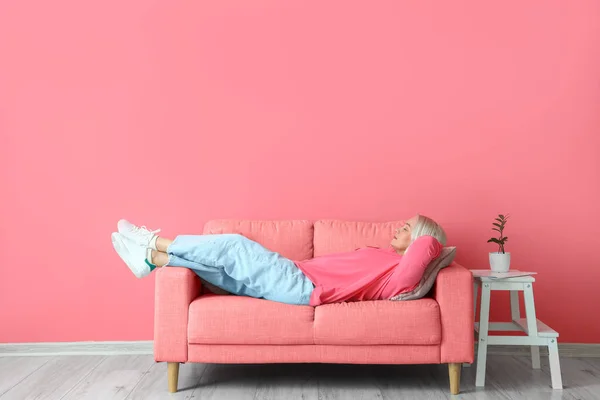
[154,220,473,393]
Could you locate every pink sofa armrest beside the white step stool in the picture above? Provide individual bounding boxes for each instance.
[434,262,474,363]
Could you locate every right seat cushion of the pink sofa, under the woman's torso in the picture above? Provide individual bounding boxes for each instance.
[314,298,442,346]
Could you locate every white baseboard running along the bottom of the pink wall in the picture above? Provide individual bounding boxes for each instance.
[0,340,600,357]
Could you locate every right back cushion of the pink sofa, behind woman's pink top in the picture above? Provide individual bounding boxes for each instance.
[314,219,402,257]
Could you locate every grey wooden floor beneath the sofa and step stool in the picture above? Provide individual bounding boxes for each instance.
[0,355,600,400]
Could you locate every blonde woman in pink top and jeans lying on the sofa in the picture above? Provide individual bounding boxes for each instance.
[112,215,446,306]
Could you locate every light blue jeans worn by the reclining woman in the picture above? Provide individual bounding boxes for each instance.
[167,234,314,305]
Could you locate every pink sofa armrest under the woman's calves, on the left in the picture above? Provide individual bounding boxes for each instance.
[154,267,201,362]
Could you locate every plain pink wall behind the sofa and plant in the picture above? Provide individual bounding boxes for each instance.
[0,0,600,343]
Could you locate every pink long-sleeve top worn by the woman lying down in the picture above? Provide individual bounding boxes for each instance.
[295,236,443,306]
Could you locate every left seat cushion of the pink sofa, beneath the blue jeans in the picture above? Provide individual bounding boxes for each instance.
[188,294,316,345]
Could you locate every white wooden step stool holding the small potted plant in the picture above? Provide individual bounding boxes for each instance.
[471,269,562,389]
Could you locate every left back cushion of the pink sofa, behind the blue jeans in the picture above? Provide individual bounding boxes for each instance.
[204,219,313,260]
